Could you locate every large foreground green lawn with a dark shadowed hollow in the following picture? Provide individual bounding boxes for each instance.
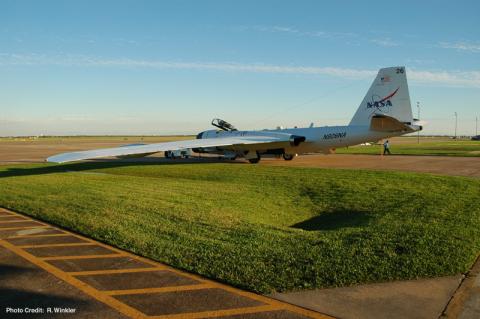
[0,162,480,293]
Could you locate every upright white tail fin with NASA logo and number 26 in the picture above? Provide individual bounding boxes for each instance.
[350,67,414,125]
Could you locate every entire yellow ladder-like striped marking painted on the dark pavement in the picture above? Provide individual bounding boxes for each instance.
[0,210,333,319]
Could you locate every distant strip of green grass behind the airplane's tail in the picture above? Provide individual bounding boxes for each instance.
[336,137,480,156]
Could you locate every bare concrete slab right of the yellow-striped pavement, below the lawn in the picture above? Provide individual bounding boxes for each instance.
[272,275,462,319]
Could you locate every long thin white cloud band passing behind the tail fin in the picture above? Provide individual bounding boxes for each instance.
[0,53,480,88]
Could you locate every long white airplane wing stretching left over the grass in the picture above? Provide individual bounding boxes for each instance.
[47,134,290,163]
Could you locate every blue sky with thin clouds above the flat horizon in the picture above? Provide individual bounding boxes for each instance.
[0,0,480,135]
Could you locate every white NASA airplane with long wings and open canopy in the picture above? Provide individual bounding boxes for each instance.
[47,67,423,163]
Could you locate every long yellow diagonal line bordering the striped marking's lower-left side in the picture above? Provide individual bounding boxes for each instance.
[0,239,146,318]
